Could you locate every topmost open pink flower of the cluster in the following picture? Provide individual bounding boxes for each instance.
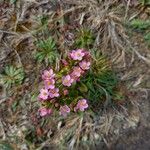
[70,49,85,60]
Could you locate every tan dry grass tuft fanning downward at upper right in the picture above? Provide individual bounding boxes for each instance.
[59,0,150,68]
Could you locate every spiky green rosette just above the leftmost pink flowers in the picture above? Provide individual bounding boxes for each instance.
[35,37,58,65]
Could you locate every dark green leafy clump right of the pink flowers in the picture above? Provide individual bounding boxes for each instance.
[81,71,118,108]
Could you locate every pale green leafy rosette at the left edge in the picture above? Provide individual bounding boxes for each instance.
[0,66,25,88]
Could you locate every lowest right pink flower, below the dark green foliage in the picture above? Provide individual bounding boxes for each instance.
[74,99,88,111]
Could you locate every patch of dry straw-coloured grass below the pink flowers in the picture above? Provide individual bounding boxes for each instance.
[43,103,144,149]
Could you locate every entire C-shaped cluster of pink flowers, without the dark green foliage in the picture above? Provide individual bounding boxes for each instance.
[39,49,91,117]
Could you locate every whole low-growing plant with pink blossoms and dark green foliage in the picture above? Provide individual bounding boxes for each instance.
[39,49,118,116]
